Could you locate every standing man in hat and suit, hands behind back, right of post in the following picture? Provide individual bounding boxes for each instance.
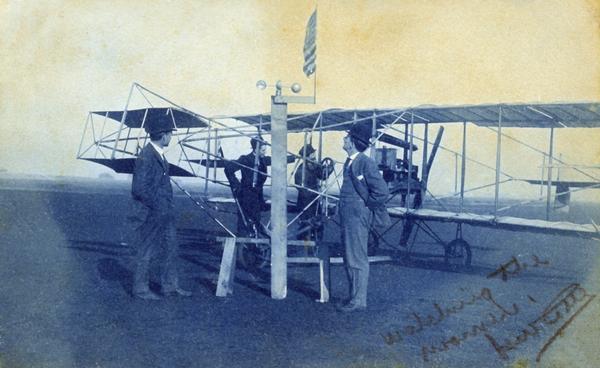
[338,122,389,312]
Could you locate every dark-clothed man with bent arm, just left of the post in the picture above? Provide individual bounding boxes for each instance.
[225,136,270,236]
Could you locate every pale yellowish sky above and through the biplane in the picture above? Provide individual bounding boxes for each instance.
[0,0,600,200]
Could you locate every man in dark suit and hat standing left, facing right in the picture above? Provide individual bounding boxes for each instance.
[131,116,192,300]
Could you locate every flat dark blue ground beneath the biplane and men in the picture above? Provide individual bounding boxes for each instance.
[0,179,600,368]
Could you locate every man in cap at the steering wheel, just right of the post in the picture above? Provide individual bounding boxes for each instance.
[294,144,333,240]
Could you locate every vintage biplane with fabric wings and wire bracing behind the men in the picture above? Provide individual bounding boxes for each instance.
[77,83,600,274]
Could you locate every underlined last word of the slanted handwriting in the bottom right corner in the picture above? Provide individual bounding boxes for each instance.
[485,284,596,362]
